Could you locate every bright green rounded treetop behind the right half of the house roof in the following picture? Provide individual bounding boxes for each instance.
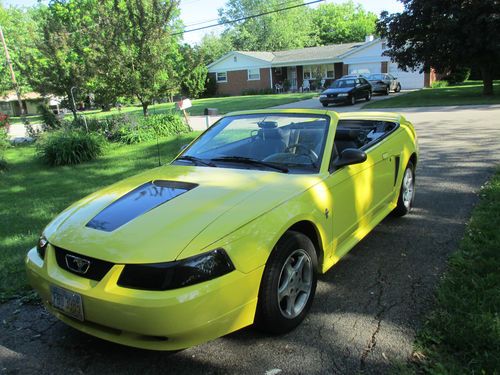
[312,1,377,45]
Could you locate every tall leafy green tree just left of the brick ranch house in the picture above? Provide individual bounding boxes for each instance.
[101,0,185,116]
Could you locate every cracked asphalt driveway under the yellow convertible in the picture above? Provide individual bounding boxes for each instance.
[0,103,500,374]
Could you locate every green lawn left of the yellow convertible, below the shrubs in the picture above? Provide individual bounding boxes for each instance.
[0,133,197,301]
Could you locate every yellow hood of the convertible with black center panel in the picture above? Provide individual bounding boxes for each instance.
[44,165,318,263]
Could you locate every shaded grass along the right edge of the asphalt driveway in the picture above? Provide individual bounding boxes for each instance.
[410,169,500,375]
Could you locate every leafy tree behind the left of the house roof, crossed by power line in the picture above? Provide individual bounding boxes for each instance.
[219,0,315,51]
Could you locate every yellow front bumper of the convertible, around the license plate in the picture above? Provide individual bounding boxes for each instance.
[26,245,264,350]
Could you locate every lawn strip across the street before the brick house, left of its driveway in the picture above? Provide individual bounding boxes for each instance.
[11,92,318,124]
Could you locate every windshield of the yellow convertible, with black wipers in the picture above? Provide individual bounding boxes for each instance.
[174,114,329,173]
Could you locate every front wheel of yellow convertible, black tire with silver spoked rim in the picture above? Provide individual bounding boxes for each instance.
[255,231,318,334]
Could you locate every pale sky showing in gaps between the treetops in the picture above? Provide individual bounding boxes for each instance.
[2,0,403,44]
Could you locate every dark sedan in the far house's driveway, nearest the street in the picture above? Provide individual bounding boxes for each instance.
[319,77,372,107]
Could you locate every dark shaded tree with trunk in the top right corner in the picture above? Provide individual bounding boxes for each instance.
[377,0,500,95]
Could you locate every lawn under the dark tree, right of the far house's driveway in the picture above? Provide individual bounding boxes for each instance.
[363,81,500,108]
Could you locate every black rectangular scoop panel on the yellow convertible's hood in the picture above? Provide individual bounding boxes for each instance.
[86,180,198,232]
